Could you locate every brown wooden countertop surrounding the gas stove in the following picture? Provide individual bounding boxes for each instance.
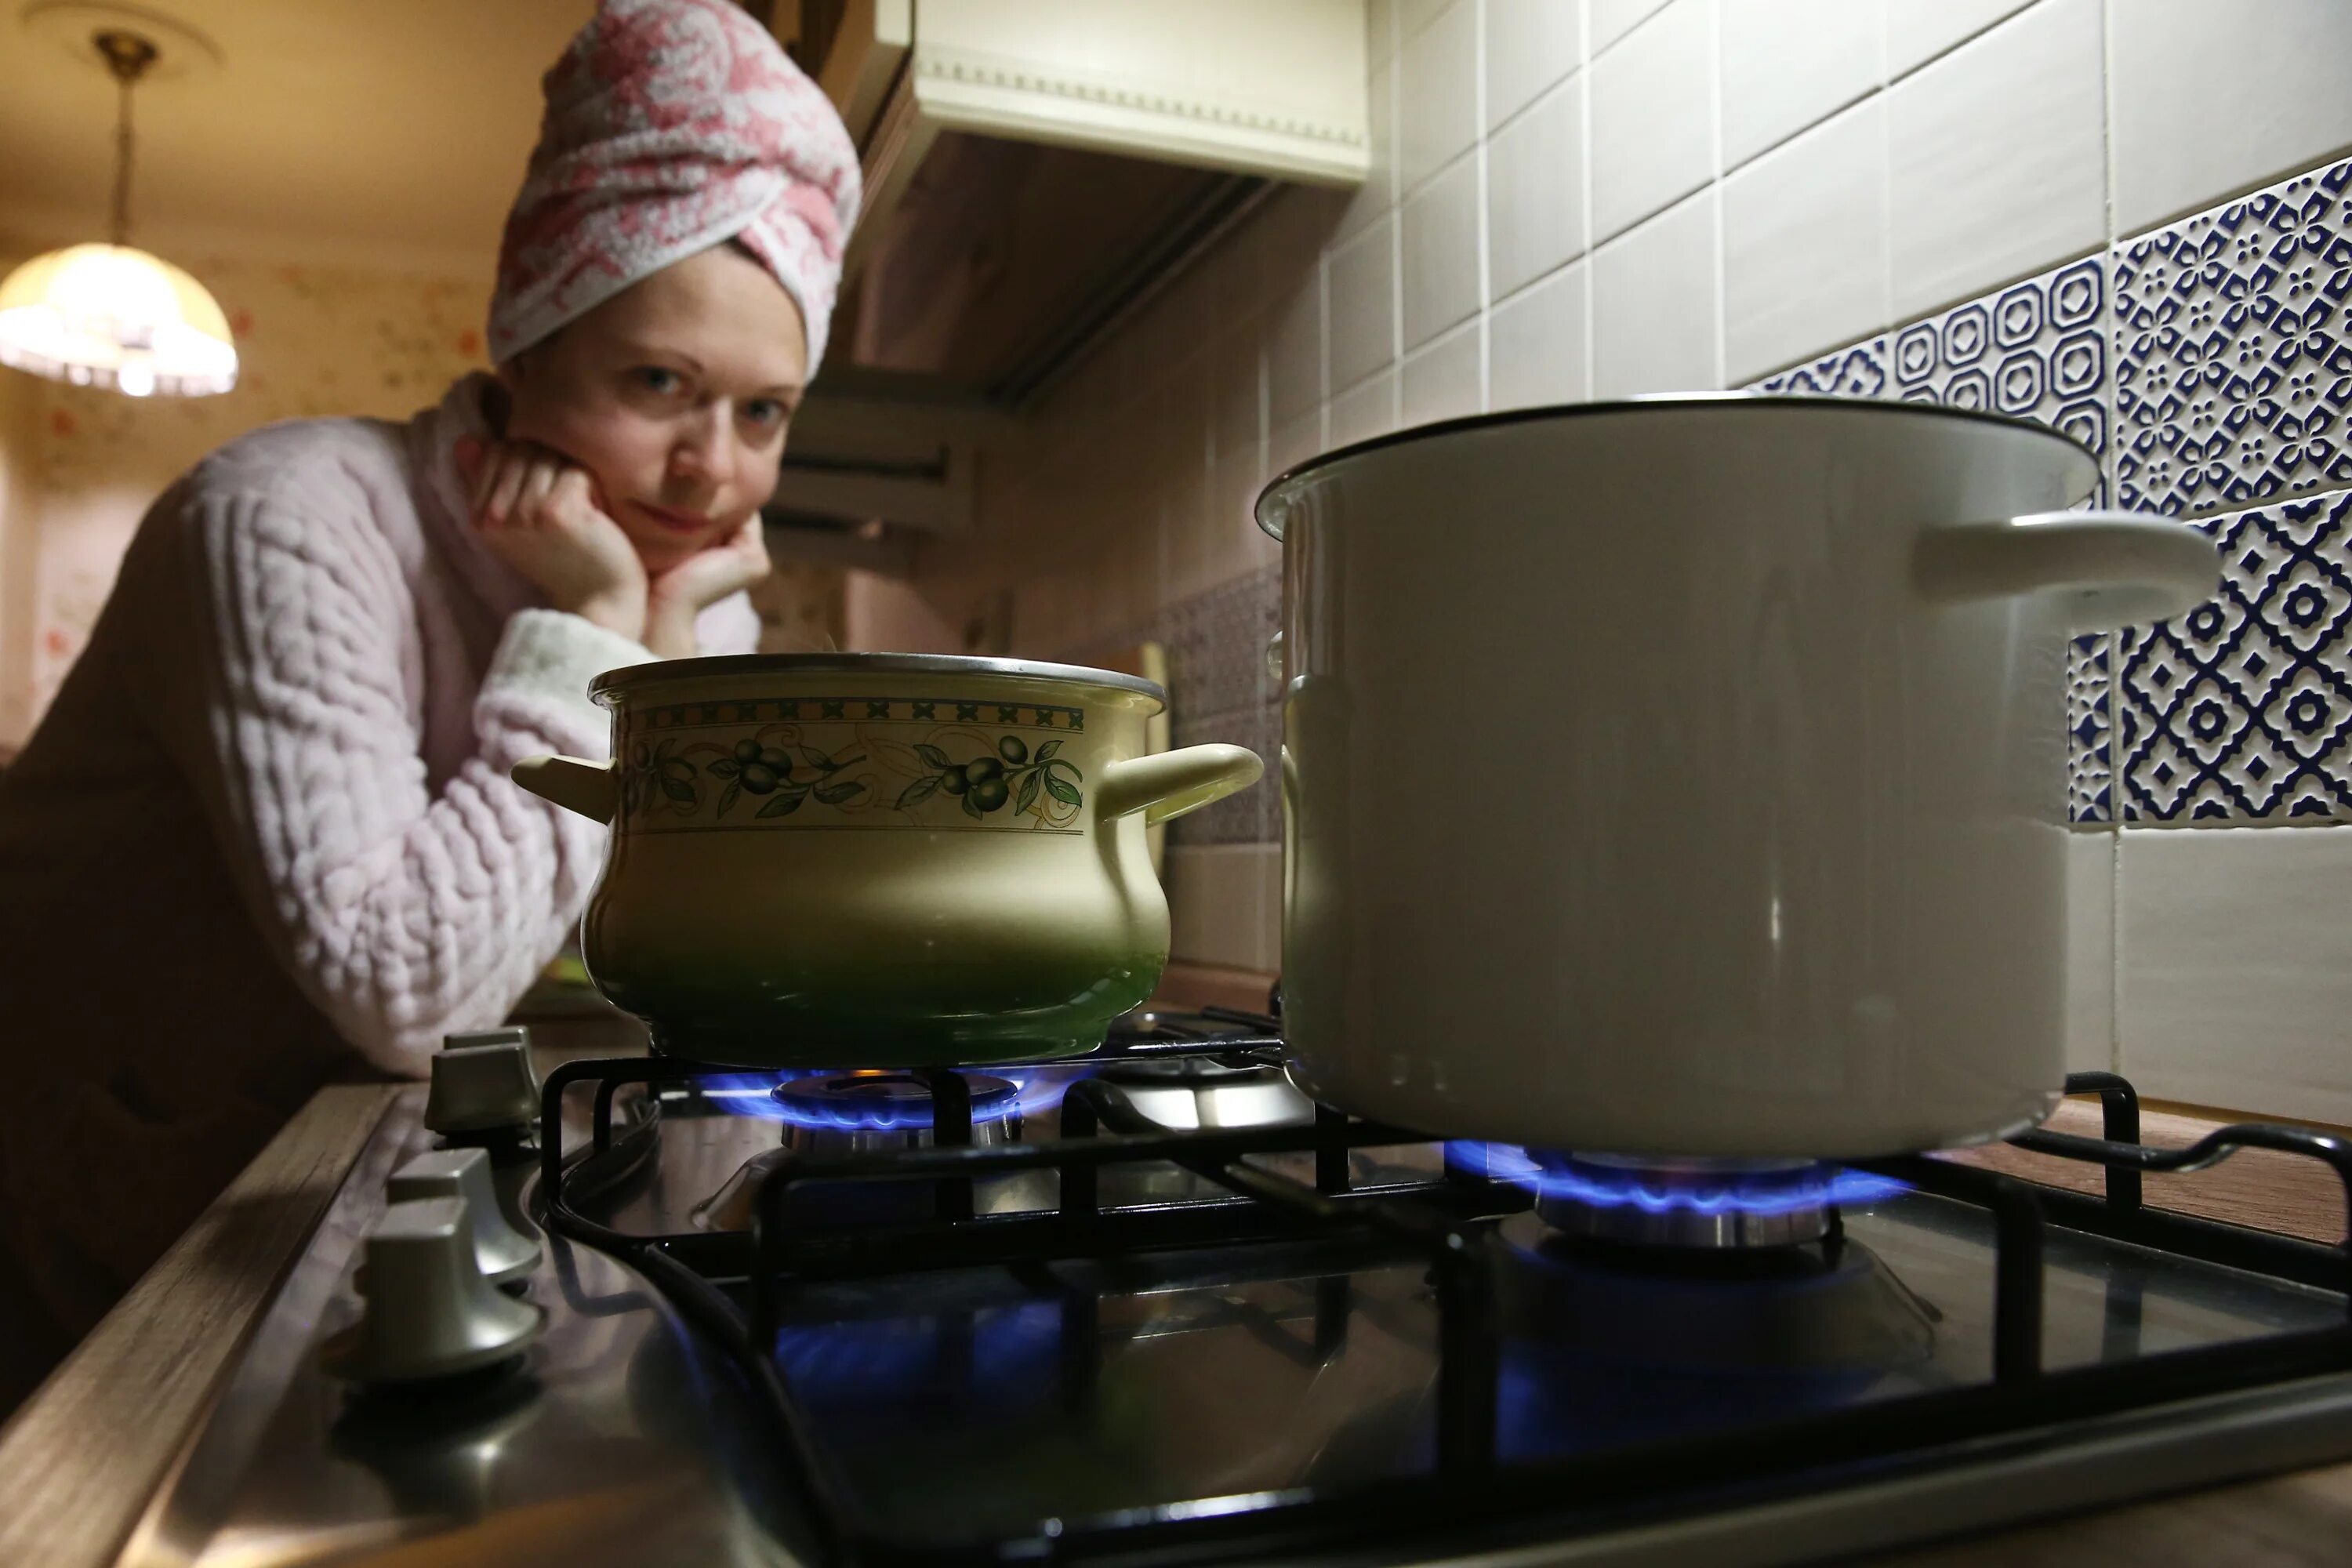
[0,1081,2352,1568]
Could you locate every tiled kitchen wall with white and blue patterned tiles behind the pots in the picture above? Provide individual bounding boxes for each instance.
[849,0,2352,1123]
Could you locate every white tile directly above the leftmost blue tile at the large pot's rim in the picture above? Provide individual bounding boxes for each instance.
[1724,99,1889,386]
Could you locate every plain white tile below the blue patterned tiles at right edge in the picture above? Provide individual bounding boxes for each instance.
[2117,827,2352,1123]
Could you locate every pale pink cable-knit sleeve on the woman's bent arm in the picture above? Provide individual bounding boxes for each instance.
[191,492,652,1074]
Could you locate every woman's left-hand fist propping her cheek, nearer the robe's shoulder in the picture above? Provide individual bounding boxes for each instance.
[456,440,649,642]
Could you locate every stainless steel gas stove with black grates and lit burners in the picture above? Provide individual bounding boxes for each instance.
[127,1013,2352,1563]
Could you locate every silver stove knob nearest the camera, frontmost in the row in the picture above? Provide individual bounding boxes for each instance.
[322,1199,548,1382]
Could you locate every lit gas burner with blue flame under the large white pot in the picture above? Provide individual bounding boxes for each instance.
[1446,1142,1903,1250]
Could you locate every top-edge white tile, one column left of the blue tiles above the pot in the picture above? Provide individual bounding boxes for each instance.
[1590,0,1715,240]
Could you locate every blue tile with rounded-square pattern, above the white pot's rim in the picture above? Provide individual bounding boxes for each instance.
[1891,256,2107,491]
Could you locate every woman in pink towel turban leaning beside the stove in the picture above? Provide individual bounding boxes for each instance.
[0,0,858,1413]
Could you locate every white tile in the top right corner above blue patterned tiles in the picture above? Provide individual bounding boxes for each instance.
[2107,0,2352,235]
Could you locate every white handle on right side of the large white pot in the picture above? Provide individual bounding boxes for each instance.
[1912,513,2220,633]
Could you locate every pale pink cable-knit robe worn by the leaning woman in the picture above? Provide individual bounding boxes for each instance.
[0,376,760,1335]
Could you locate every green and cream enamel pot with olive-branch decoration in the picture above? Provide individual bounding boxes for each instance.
[515,654,1263,1067]
